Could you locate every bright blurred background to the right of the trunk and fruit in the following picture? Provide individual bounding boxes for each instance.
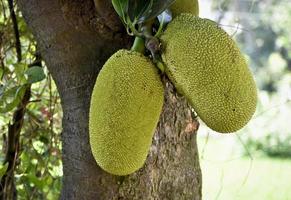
[198,0,291,200]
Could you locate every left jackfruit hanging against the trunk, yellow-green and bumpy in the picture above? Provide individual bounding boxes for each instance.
[89,50,164,176]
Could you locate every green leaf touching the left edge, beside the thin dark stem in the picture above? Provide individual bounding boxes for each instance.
[0,85,27,113]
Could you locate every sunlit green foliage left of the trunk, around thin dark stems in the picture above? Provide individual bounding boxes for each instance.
[0,1,62,199]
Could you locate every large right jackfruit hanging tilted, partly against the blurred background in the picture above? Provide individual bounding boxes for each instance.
[161,14,257,133]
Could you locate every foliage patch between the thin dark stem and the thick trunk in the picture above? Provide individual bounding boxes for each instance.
[16,76,62,199]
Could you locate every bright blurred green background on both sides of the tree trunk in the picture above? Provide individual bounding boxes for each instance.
[0,0,291,200]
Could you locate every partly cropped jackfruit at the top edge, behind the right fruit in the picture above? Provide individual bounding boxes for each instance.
[170,0,199,17]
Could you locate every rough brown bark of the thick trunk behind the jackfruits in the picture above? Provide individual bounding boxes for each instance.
[18,0,201,200]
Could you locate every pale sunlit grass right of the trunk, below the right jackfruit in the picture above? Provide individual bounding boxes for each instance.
[198,135,291,200]
